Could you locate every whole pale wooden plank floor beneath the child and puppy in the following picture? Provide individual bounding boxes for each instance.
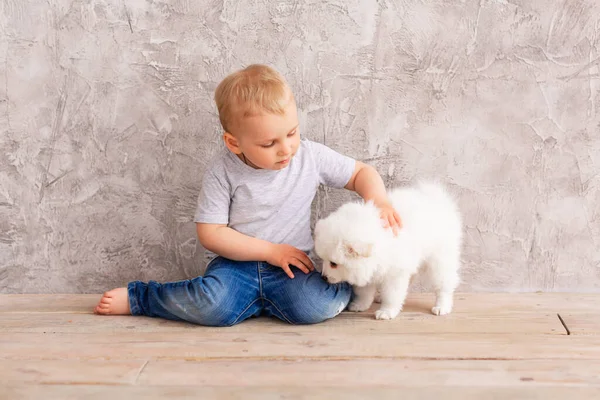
[0,294,600,400]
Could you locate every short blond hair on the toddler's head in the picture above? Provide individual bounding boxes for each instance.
[215,64,289,133]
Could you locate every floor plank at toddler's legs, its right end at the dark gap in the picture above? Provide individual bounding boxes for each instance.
[0,312,566,335]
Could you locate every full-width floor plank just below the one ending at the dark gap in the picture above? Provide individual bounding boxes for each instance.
[0,328,600,360]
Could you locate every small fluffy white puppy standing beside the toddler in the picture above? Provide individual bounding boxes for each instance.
[315,183,462,319]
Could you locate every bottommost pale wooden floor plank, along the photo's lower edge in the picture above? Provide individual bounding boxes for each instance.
[0,384,600,400]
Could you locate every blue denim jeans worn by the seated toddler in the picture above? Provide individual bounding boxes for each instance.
[127,257,352,326]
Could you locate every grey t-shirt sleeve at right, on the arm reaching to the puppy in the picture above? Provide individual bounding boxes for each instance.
[307,141,356,189]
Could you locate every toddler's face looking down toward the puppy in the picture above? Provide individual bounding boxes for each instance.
[225,96,300,170]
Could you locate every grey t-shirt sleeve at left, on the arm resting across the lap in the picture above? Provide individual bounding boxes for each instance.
[194,169,231,225]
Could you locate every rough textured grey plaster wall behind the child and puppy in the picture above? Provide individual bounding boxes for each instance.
[0,0,600,293]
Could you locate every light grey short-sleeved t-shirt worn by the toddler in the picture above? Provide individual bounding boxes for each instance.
[194,139,355,261]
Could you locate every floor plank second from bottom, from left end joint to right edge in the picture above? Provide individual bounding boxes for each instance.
[138,360,600,387]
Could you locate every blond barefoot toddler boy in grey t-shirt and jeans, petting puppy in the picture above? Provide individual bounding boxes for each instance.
[94,65,400,326]
